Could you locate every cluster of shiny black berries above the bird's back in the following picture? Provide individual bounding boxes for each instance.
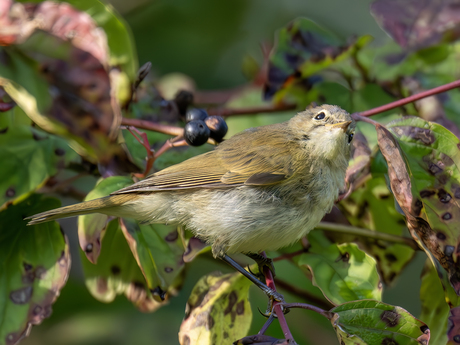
[184,108,228,146]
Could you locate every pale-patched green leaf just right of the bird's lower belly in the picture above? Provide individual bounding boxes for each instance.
[298,231,382,305]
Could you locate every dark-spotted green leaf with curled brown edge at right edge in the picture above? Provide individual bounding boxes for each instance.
[376,117,460,294]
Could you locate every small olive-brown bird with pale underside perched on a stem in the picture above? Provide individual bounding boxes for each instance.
[29,105,356,298]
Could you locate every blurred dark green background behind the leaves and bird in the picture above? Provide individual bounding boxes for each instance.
[22,0,424,345]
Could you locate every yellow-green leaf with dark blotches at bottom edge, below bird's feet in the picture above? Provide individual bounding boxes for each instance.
[179,273,252,345]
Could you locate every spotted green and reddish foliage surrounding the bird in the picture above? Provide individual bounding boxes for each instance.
[0,0,460,345]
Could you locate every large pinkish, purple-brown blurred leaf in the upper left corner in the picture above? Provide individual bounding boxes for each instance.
[0,1,131,164]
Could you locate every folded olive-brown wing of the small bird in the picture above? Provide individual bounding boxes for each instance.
[112,124,292,194]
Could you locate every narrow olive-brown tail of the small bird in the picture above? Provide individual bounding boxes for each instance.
[25,194,133,225]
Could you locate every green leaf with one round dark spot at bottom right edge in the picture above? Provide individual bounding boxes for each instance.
[331,300,430,345]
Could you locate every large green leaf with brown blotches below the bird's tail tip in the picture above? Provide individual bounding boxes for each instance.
[0,194,70,344]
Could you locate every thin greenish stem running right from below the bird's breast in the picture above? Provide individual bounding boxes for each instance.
[315,222,420,250]
